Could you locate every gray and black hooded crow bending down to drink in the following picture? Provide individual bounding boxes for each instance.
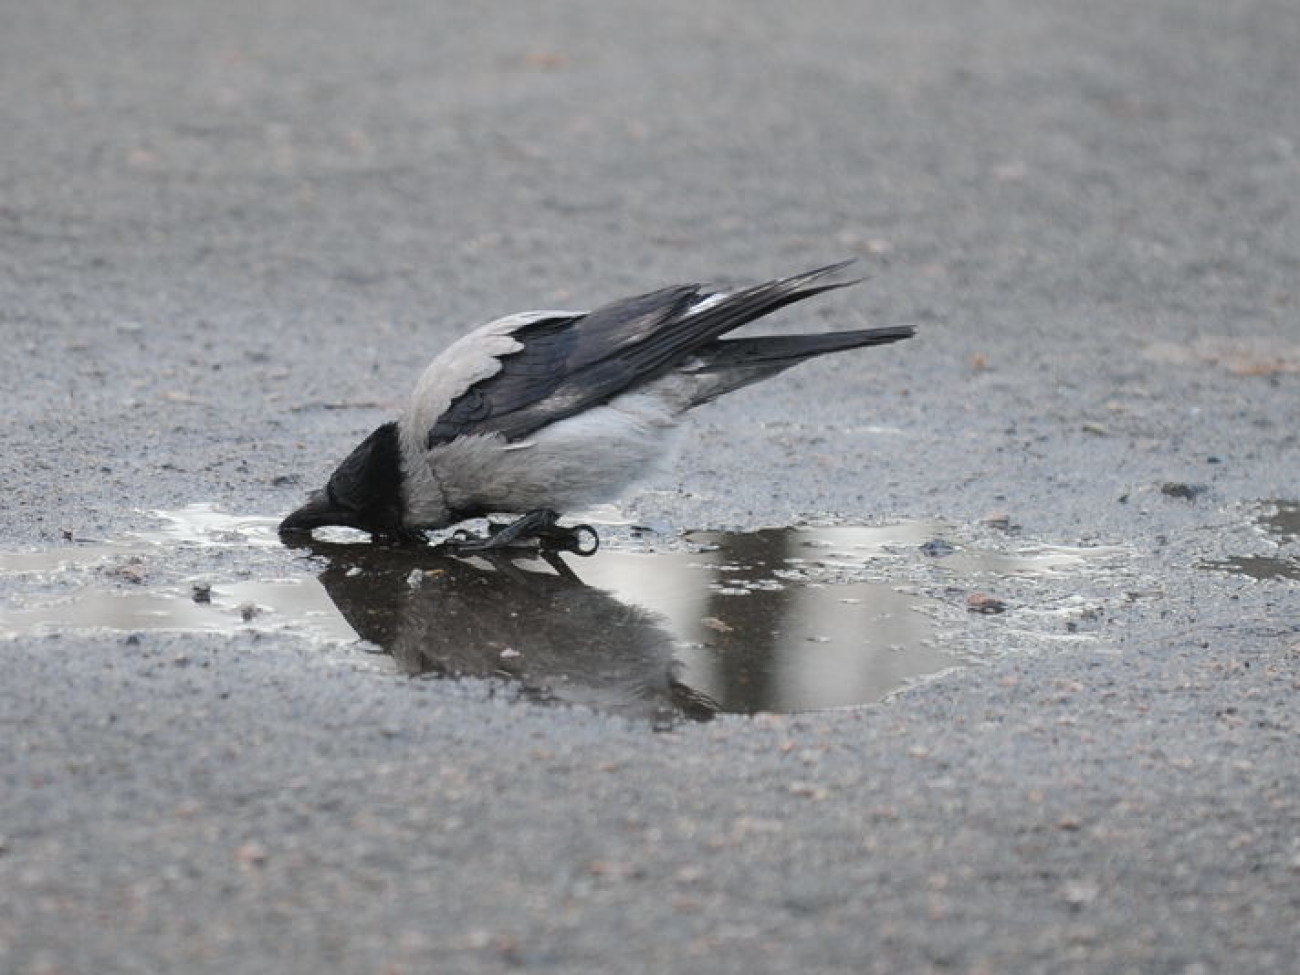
[280,263,913,547]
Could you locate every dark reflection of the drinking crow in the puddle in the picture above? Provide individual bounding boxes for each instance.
[300,542,718,727]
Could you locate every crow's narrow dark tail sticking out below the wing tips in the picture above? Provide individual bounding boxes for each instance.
[681,325,915,407]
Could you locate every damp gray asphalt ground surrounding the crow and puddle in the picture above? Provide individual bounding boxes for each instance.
[0,0,1300,972]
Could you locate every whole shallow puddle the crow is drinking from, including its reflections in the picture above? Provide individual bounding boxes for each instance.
[0,506,1122,719]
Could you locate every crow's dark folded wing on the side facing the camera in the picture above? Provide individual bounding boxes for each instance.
[428,261,854,447]
